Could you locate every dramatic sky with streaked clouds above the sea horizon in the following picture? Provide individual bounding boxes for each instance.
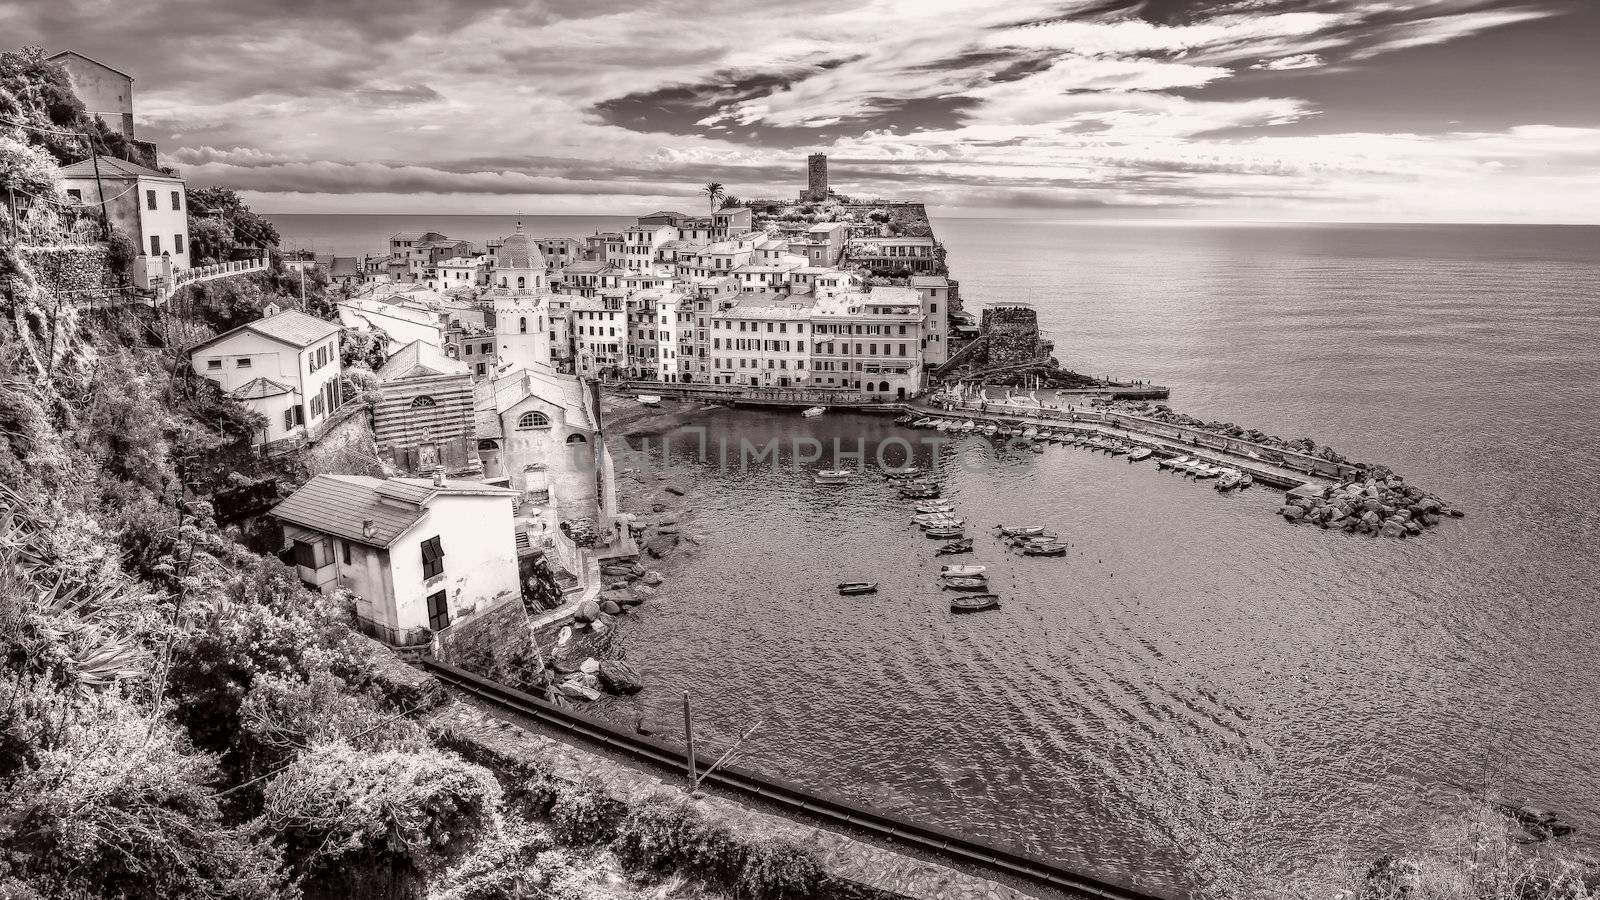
[0,0,1600,223]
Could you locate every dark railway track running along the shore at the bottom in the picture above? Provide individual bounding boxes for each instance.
[421,657,1173,900]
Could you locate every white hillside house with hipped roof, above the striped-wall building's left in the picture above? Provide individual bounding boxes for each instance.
[189,309,344,444]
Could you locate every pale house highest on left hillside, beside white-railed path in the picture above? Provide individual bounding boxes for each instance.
[61,157,194,288]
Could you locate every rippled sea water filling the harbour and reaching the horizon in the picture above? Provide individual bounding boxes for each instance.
[274,216,1600,895]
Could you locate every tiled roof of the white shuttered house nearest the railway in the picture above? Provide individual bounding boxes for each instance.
[272,476,517,548]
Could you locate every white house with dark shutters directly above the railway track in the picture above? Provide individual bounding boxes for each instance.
[270,476,522,647]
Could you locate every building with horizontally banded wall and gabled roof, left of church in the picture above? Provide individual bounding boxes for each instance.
[373,341,480,476]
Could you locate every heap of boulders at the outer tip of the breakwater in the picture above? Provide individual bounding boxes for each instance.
[1278,474,1462,538]
